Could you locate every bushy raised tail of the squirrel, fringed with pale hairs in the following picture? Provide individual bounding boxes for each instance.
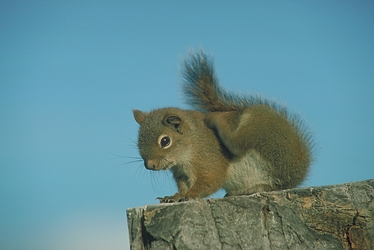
[182,50,287,115]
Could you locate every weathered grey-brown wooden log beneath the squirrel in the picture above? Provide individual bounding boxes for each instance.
[127,180,374,250]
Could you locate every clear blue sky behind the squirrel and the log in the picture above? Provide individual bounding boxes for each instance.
[0,1,374,250]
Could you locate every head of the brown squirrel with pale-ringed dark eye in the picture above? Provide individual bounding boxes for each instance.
[133,108,188,170]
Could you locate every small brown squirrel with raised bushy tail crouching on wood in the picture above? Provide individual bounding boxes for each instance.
[133,51,312,203]
